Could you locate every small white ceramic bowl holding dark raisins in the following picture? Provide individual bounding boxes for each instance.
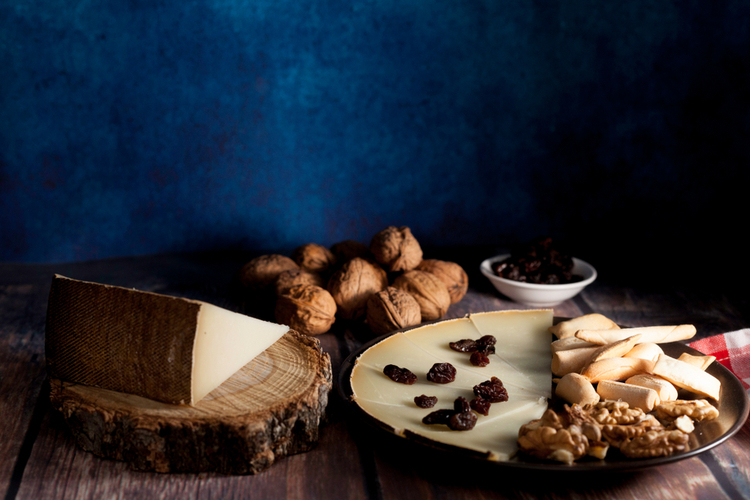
[479,254,596,307]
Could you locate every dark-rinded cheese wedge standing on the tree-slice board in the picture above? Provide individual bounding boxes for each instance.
[45,275,289,405]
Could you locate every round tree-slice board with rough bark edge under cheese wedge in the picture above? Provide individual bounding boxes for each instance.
[50,331,332,474]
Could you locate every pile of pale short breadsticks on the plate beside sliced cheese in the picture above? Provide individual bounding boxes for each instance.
[550,314,721,412]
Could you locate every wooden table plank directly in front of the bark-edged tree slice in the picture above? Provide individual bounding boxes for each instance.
[16,408,374,500]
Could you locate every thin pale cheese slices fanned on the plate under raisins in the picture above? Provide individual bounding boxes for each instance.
[350,310,552,461]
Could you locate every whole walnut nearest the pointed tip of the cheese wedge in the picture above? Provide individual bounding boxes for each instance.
[276,285,336,335]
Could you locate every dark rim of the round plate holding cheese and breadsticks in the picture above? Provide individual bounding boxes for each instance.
[336,313,750,473]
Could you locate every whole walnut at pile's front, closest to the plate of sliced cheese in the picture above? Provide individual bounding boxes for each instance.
[367,286,422,335]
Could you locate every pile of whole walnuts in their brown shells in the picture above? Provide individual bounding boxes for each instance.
[240,226,469,335]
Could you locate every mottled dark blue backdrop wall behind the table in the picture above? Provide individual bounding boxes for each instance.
[0,0,750,278]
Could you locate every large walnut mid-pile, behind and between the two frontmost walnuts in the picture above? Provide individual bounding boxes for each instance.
[328,257,388,319]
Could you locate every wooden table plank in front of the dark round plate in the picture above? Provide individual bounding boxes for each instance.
[364,430,736,499]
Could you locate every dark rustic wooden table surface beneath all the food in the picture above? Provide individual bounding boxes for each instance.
[0,253,750,500]
